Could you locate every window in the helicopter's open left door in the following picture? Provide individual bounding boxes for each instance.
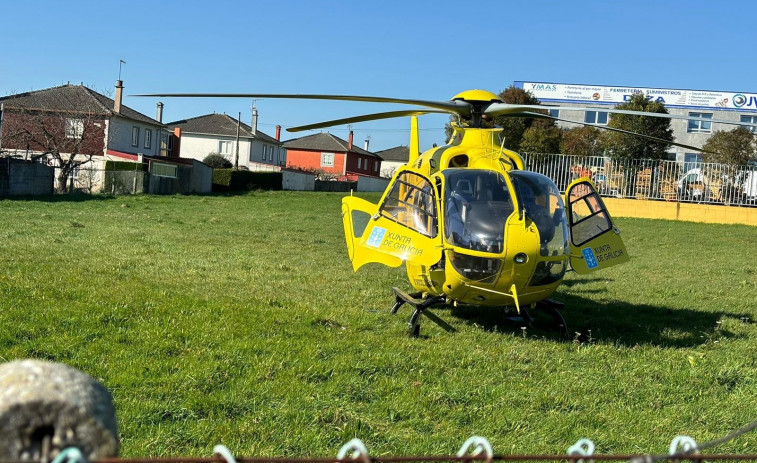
[379,172,438,238]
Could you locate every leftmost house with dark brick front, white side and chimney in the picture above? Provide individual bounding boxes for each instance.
[0,80,167,187]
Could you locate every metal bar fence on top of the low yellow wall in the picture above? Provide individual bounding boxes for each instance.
[524,154,757,206]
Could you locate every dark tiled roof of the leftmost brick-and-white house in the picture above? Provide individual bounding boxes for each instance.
[0,84,163,126]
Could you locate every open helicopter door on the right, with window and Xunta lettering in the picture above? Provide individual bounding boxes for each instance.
[565,177,629,273]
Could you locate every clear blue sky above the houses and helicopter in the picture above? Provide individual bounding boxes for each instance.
[0,0,757,150]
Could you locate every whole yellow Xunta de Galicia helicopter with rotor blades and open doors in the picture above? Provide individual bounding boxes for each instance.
[140,90,728,336]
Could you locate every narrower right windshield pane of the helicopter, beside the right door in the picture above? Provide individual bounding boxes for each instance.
[510,171,570,256]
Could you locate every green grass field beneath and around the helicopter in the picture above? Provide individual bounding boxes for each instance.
[0,192,757,456]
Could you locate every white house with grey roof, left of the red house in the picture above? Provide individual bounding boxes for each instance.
[168,112,286,170]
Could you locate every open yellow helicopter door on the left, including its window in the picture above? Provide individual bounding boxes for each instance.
[342,170,442,271]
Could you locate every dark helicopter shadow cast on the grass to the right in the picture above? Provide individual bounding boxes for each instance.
[416,294,742,348]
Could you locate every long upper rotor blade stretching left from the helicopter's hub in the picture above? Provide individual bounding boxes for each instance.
[132,93,471,117]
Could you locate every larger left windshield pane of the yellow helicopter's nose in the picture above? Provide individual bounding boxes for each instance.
[443,169,514,253]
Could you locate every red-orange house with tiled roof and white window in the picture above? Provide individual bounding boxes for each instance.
[284,132,381,181]
